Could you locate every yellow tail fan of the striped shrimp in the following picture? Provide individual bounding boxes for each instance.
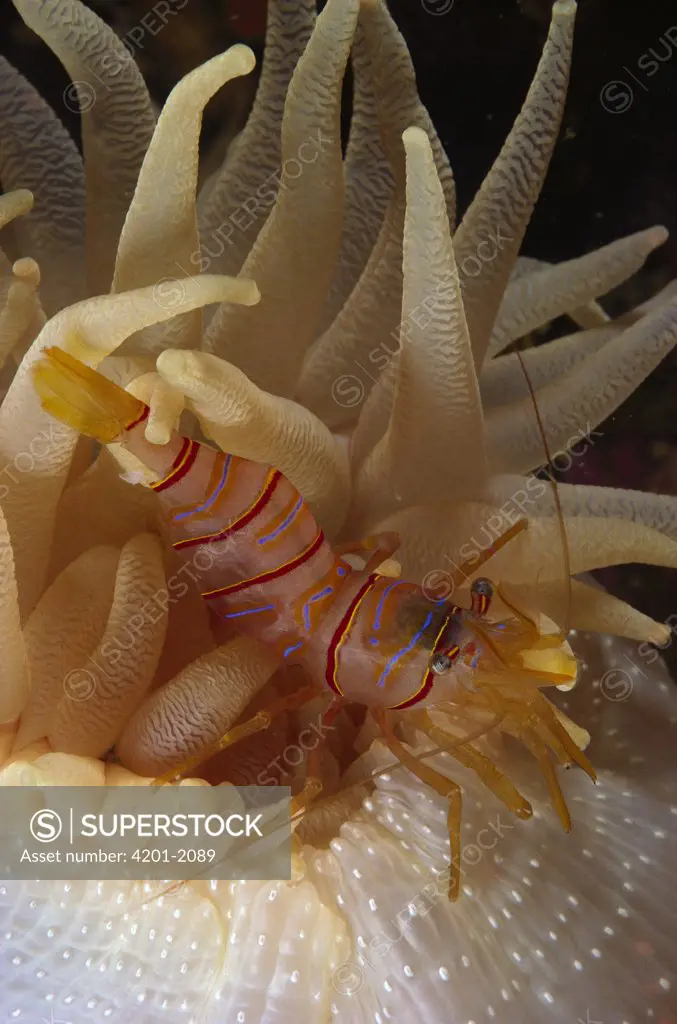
[32,347,147,444]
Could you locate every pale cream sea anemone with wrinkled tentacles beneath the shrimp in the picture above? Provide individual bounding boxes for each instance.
[0,0,677,1024]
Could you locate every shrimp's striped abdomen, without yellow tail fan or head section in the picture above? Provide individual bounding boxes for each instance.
[120,414,350,657]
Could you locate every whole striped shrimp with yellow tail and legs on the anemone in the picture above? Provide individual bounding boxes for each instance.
[34,348,595,899]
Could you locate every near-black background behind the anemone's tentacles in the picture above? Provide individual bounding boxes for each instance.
[0,0,677,647]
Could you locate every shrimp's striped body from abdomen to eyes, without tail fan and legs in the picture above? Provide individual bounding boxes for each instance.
[98,407,508,710]
